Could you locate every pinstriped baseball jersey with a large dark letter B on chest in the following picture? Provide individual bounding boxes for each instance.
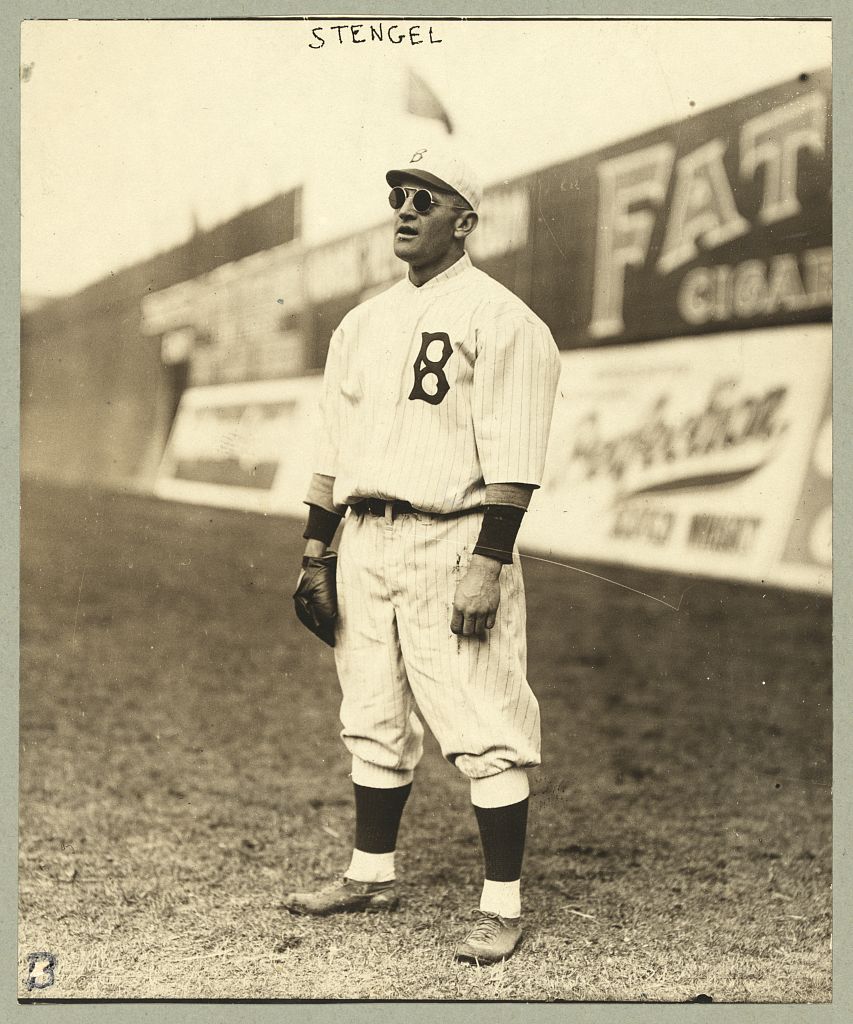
[315,254,560,512]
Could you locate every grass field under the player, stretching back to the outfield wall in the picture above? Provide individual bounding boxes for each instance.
[19,484,831,1002]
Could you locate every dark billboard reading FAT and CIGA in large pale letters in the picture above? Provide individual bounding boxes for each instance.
[524,71,831,348]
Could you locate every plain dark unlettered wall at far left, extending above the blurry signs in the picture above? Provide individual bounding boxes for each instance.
[20,196,301,489]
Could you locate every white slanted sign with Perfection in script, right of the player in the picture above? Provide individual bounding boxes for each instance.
[522,326,831,589]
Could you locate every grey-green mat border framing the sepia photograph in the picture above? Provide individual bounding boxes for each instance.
[0,0,853,1024]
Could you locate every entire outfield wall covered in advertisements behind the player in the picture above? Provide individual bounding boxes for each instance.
[22,71,833,590]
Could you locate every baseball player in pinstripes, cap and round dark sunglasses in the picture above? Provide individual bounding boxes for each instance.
[285,146,559,963]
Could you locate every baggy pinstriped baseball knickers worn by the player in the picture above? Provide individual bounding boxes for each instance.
[335,512,540,787]
